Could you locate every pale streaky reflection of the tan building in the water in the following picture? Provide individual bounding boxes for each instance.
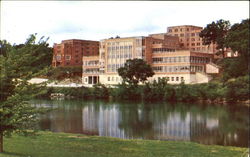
[82,105,225,143]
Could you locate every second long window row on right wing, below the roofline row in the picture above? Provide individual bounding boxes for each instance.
[152,65,204,72]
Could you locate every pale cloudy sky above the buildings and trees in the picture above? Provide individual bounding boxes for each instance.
[0,1,249,46]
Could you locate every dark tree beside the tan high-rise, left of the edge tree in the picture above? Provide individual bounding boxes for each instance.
[200,19,230,58]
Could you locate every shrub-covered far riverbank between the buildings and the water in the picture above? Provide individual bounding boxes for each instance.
[38,76,249,105]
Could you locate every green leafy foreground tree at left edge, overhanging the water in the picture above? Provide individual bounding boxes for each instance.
[0,35,49,152]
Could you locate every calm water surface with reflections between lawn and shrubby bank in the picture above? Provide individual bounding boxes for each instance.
[32,100,249,147]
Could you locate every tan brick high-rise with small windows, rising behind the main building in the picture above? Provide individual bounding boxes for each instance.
[167,25,216,54]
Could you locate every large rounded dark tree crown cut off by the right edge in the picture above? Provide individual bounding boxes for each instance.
[226,19,250,64]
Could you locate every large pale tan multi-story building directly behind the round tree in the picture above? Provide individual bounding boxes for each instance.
[83,33,219,85]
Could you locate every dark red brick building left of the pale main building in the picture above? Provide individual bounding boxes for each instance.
[52,39,99,67]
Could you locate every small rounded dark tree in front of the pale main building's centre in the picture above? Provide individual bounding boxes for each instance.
[118,59,154,86]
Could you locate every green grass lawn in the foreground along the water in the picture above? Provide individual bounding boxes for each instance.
[0,132,248,157]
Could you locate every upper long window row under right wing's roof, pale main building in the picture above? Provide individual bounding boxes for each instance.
[152,56,210,63]
